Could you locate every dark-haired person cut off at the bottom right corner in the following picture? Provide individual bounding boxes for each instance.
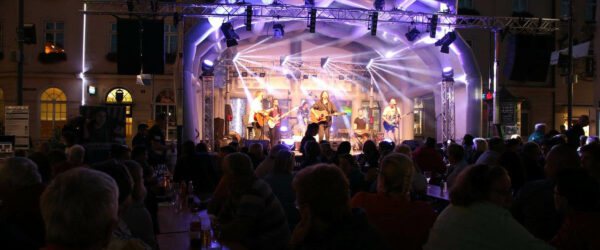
[550,168,600,249]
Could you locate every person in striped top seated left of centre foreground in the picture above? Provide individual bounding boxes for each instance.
[217,153,290,249]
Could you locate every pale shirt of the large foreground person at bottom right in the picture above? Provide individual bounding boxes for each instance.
[423,202,553,250]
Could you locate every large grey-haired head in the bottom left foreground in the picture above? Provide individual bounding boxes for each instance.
[40,168,119,249]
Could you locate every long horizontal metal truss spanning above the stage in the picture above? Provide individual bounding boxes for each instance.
[82,0,560,34]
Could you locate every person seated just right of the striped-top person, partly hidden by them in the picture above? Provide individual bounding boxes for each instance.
[265,150,300,231]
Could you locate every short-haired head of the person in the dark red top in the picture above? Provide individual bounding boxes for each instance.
[377,153,415,195]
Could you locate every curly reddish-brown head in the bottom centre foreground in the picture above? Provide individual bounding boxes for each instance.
[292,164,350,224]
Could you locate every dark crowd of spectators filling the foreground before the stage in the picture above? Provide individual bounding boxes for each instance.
[0,115,600,249]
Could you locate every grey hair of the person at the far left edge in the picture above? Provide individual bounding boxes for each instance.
[0,157,42,188]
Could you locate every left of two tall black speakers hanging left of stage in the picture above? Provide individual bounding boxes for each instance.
[117,18,141,75]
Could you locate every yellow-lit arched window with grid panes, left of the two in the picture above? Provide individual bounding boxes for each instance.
[40,88,67,138]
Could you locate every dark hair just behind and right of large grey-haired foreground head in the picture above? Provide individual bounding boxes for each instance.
[92,160,133,217]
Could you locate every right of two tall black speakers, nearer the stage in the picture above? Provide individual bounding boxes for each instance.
[142,19,165,75]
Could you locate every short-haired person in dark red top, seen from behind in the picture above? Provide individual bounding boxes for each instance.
[350,153,435,249]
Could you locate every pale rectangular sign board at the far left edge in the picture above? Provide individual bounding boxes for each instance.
[4,106,29,150]
